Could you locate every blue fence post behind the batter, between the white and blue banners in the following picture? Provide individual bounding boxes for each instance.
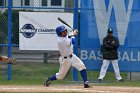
[73,0,78,81]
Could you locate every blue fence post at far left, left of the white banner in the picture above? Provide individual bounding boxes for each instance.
[7,0,12,80]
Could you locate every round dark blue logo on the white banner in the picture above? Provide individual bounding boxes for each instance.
[20,24,37,38]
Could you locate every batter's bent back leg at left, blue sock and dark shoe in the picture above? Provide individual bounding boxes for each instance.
[45,58,71,86]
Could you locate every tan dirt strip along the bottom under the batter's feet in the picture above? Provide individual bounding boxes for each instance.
[0,85,140,93]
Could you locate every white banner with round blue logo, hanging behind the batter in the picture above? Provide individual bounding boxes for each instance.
[19,12,73,50]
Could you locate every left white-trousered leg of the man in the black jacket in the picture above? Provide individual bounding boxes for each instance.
[98,59,110,81]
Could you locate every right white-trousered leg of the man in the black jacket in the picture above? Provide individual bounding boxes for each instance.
[111,60,122,81]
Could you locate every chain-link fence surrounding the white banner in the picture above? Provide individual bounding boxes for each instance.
[0,0,74,62]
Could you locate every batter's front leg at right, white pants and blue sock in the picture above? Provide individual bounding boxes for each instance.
[71,54,90,88]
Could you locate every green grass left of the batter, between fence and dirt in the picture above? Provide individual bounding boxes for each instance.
[0,63,72,85]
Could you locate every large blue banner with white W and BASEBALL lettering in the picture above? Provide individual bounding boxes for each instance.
[80,0,140,71]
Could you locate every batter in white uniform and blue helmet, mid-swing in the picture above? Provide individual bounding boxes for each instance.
[45,26,90,88]
